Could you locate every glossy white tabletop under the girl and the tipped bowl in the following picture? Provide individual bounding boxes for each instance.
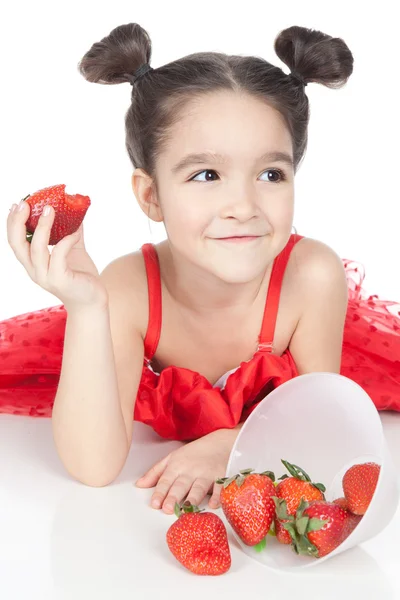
[0,412,400,600]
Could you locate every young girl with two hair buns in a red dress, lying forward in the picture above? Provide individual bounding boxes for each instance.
[0,23,400,513]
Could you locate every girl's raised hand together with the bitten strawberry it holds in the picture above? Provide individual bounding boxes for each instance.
[7,185,109,312]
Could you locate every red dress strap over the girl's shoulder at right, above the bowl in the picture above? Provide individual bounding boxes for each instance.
[257,233,304,352]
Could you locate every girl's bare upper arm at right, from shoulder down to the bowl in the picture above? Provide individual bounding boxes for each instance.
[289,239,348,375]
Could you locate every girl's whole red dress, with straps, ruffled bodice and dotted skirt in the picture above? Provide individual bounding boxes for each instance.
[0,234,400,441]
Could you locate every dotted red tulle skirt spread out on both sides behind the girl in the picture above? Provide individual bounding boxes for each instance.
[0,259,400,417]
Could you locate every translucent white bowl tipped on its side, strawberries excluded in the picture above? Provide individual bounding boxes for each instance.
[225,372,400,570]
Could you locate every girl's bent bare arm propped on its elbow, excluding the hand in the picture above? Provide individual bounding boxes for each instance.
[52,259,144,487]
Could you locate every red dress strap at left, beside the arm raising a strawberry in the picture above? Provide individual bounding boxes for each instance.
[141,243,162,364]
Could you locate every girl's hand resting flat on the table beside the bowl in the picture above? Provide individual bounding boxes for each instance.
[136,429,238,514]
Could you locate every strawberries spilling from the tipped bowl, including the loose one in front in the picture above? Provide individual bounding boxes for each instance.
[166,460,380,575]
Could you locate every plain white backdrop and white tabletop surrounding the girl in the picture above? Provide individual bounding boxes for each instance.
[0,0,400,600]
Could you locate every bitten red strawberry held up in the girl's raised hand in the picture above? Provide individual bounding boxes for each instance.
[23,184,90,246]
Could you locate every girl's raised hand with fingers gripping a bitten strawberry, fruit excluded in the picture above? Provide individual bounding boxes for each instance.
[7,202,108,310]
